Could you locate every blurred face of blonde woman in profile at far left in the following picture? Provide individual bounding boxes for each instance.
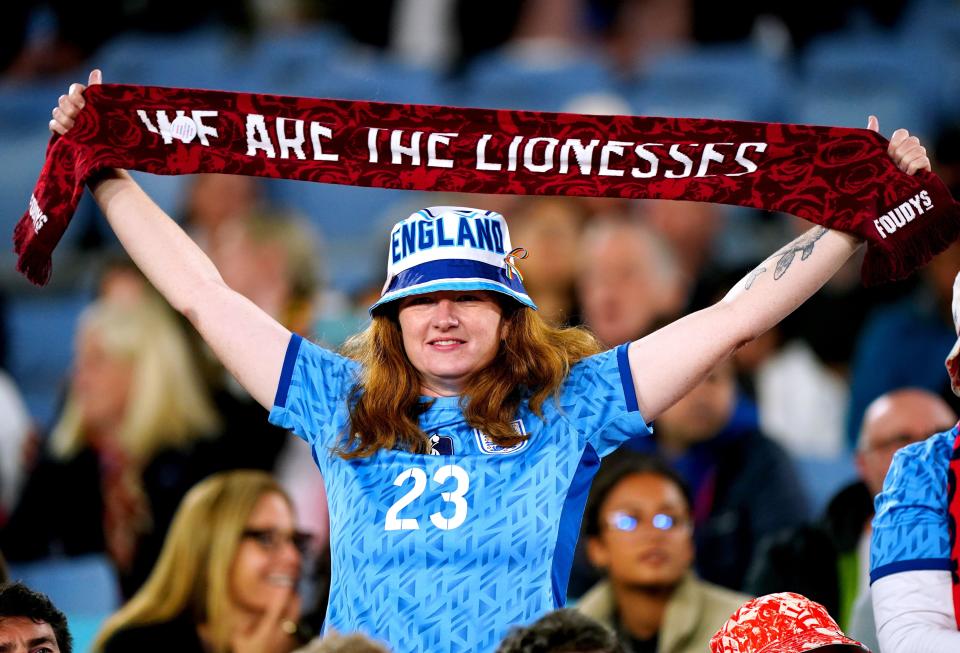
[72,330,133,431]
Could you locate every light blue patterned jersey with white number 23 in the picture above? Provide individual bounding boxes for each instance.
[270,335,649,651]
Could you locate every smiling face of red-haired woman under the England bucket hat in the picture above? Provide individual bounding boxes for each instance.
[399,290,506,397]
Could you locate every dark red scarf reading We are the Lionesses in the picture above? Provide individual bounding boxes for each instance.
[14,84,960,284]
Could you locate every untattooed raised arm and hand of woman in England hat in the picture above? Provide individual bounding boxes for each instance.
[50,70,290,409]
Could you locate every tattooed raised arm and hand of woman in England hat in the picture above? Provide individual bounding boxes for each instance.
[629,116,930,420]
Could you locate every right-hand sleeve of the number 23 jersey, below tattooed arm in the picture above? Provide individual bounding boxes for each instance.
[560,343,651,457]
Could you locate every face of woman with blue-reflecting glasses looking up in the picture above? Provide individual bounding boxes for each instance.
[587,473,693,588]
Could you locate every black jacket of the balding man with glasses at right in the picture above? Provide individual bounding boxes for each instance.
[745,481,873,622]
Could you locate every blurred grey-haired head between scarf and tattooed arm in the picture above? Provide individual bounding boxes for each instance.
[577,215,686,347]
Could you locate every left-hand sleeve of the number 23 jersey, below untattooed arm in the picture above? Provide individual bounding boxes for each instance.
[270,334,360,446]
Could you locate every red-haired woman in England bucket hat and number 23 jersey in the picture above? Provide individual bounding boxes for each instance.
[50,71,929,652]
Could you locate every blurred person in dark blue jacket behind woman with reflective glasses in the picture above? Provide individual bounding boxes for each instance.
[628,361,808,590]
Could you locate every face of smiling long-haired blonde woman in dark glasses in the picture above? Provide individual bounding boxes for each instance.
[230,492,301,613]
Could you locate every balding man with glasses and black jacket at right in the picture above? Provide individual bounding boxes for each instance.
[746,388,957,641]
